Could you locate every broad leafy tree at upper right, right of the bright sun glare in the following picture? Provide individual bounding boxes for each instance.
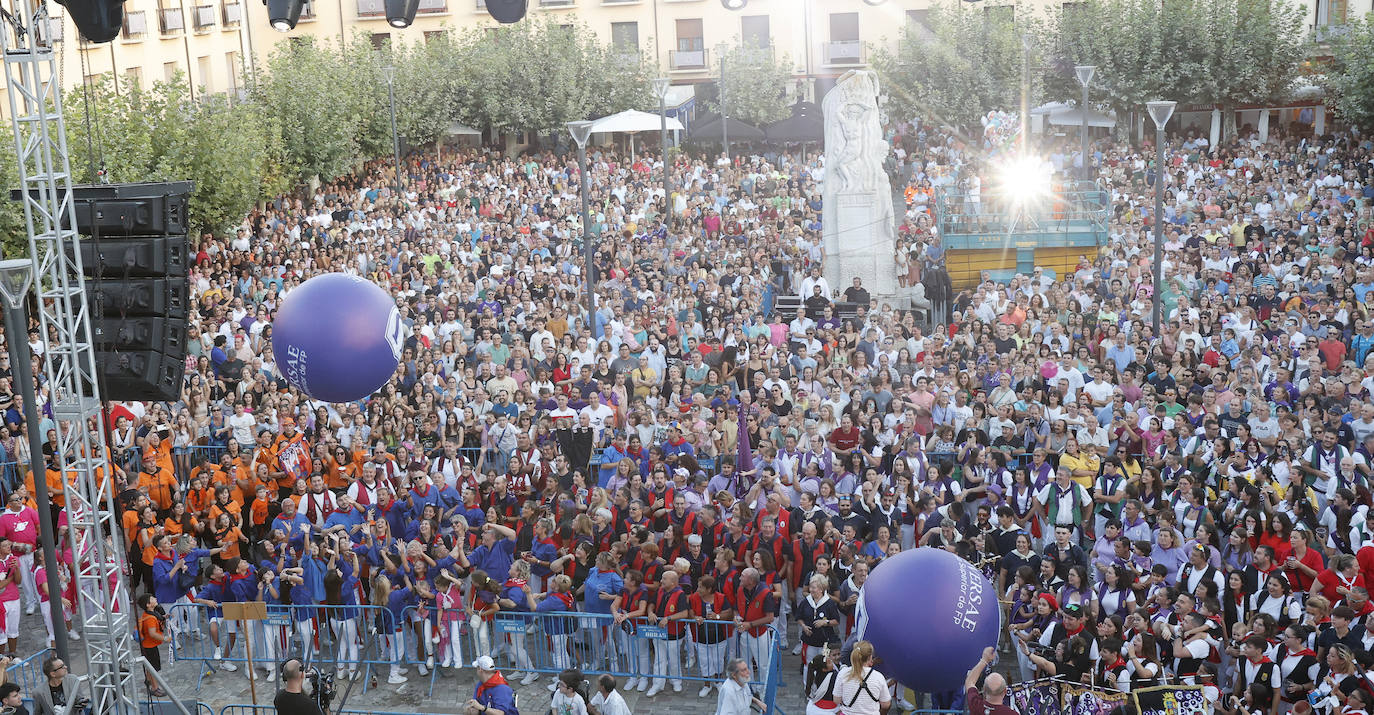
[1046,0,1304,136]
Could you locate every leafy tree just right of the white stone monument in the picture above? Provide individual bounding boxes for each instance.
[872,1,1039,129]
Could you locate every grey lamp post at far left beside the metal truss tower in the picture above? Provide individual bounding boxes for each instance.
[0,259,69,661]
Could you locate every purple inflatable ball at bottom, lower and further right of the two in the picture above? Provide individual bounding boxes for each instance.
[855,549,1002,693]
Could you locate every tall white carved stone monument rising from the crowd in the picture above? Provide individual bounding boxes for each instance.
[822,70,899,300]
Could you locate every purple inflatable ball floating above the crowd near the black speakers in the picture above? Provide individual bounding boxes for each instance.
[272,274,403,403]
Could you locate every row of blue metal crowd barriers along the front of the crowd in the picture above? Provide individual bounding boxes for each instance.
[168,604,782,715]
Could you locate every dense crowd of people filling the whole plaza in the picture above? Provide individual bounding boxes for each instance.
[0,113,1374,715]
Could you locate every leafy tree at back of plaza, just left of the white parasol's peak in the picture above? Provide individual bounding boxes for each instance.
[455,17,651,132]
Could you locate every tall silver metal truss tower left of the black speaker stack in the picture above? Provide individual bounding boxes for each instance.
[0,0,142,715]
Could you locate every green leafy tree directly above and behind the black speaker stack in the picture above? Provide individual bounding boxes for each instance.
[67,77,280,232]
